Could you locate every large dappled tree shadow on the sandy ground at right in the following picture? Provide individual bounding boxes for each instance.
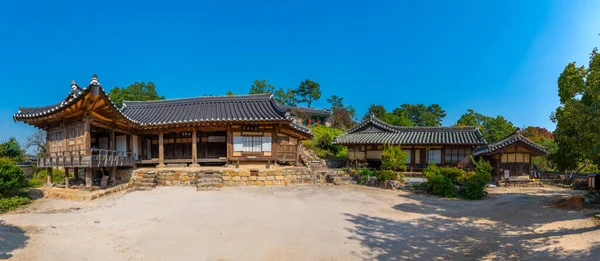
[344,190,600,261]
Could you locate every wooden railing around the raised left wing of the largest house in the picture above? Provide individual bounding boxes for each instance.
[38,149,135,168]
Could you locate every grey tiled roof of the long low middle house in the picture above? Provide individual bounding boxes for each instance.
[334,116,486,145]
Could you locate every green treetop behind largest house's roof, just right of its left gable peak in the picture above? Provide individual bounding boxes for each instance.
[108,82,165,108]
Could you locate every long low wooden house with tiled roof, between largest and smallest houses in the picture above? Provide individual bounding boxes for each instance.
[334,115,487,171]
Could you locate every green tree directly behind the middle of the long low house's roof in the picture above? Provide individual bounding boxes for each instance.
[393,103,446,126]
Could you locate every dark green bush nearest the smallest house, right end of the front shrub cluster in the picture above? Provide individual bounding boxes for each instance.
[460,158,492,199]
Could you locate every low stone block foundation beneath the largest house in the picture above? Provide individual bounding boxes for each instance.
[131,167,351,186]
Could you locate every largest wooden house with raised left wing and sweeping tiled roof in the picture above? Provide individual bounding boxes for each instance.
[13,75,312,185]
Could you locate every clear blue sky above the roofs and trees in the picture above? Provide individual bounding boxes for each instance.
[0,0,600,147]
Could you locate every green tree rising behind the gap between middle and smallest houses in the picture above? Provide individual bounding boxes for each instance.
[456,109,517,143]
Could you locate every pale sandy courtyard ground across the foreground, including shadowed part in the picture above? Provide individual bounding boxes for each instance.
[0,186,600,261]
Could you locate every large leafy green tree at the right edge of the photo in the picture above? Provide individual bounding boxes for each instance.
[550,48,600,172]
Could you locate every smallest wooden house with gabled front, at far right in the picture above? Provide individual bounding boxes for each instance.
[473,128,546,182]
